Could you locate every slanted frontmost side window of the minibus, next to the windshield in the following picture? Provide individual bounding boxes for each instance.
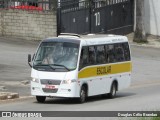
[79,47,88,70]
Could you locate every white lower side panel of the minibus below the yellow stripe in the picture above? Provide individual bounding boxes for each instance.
[81,73,131,96]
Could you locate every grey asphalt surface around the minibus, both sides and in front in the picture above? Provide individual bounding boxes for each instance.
[0,38,160,118]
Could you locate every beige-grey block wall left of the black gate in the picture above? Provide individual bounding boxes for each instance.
[0,10,57,40]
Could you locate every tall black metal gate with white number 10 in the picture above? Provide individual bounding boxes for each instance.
[57,0,134,34]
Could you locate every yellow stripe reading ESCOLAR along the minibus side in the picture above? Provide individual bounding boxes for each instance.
[78,62,132,79]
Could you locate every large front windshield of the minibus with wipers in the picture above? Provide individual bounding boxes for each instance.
[33,42,79,72]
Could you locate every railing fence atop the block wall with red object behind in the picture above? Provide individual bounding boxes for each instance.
[0,0,57,11]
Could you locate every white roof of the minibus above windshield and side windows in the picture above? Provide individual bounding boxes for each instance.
[44,34,128,46]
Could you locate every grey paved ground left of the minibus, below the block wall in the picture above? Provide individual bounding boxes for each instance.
[0,38,39,96]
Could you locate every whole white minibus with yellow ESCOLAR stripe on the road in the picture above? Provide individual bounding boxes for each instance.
[28,34,132,103]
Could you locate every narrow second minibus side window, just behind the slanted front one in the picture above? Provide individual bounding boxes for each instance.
[88,46,96,65]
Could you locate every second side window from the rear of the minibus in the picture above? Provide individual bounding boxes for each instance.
[115,43,125,62]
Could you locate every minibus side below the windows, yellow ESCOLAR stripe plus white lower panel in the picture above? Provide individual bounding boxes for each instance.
[78,62,131,96]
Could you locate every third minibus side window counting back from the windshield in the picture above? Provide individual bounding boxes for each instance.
[96,45,106,64]
